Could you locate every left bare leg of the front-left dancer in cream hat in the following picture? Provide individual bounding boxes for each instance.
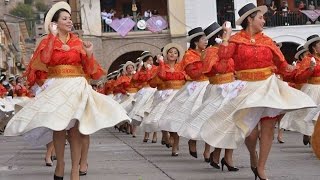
[53,130,66,177]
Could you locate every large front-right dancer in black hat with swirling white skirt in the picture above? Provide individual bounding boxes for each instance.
[202,3,315,179]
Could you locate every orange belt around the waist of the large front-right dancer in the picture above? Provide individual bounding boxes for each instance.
[236,67,273,81]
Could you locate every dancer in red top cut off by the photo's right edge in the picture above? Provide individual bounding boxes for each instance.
[282,35,320,145]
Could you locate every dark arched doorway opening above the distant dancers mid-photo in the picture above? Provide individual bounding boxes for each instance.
[108,51,143,73]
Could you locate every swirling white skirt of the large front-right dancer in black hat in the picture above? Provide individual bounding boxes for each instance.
[200,75,316,149]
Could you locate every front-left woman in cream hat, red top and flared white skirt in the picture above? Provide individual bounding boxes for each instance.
[5,2,129,180]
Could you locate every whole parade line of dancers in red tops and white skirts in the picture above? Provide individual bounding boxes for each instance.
[0,2,320,180]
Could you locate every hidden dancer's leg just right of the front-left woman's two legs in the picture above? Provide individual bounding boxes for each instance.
[80,134,90,172]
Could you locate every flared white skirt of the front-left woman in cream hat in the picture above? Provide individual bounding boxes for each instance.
[4,77,130,144]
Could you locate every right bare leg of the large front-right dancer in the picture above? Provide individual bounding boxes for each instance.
[257,118,277,179]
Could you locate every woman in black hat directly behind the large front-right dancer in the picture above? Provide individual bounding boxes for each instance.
[178,22,242,171]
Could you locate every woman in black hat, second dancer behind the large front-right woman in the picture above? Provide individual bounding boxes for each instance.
[159,27,210,159]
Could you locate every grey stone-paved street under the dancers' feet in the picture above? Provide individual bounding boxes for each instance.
[0,129,320,180]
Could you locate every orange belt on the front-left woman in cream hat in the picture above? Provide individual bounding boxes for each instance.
[48,65,86,78]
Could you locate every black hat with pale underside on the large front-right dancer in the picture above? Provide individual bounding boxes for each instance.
[236,3,268,25]
